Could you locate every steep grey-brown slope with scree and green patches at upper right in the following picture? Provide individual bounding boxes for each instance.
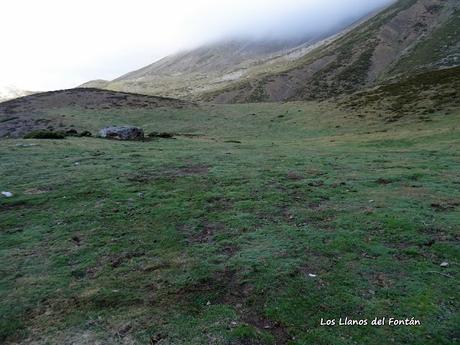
[203,0,460,102]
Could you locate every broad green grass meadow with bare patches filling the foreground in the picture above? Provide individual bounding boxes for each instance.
[0,103,460,345]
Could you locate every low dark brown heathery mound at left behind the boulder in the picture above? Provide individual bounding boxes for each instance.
[0,88,191,138]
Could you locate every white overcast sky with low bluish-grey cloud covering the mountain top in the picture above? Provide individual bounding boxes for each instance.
[0,0,392,90]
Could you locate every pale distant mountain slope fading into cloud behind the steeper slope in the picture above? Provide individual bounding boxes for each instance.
[81,11,380,99]
